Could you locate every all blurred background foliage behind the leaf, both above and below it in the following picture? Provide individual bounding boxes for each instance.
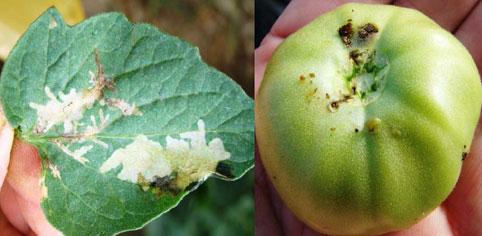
[84,0,254,236]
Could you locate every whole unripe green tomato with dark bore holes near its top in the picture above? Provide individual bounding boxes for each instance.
[256,4,482,234]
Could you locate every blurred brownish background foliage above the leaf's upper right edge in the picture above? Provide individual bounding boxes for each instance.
[84,0,254,97]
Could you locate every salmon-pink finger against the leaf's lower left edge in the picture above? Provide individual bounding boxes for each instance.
[7,139,42,204]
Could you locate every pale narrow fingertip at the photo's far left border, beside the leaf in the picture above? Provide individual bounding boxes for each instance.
[0,117,13,186]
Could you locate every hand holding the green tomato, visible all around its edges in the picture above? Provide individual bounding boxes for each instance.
[255,0,482,236]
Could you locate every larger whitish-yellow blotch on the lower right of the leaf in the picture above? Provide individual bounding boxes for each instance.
[100,120,230,189]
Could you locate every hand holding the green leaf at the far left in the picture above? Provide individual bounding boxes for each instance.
[0,109,60,236]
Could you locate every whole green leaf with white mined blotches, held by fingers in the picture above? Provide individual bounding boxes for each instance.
[0,8,254,235]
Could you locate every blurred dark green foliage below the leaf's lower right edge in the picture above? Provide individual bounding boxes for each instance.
[144,171,254,236]
